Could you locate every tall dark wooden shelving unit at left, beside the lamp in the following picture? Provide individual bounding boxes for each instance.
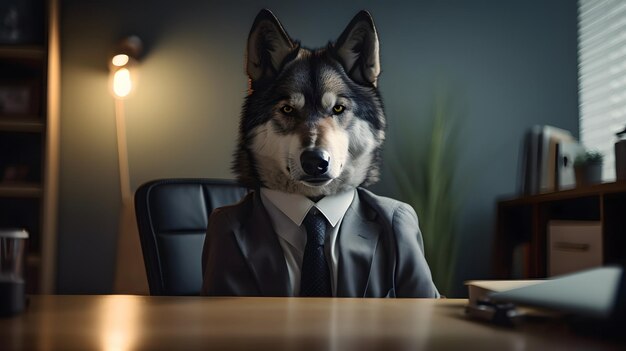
[0,0,60,293]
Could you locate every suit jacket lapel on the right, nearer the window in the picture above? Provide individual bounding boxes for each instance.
[337,191,381,297]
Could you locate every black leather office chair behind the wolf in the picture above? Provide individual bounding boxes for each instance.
[135,179,248,295]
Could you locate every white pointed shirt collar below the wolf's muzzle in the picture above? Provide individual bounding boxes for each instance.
[261,188,354,227]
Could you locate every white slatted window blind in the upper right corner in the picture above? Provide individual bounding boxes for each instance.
[578,0,626,181]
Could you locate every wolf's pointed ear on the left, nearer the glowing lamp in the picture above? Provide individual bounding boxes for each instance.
[246,9,296,81]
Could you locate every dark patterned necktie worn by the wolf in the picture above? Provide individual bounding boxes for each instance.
[300,208,332,297]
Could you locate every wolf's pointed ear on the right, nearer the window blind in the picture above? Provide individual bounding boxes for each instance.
[335,11,380,86]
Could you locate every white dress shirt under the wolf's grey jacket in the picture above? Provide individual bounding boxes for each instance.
[261,188,355,296]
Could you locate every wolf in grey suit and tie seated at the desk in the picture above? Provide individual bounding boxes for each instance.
[202,10,439,297]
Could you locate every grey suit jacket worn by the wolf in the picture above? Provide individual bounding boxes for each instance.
[202,188,439,297]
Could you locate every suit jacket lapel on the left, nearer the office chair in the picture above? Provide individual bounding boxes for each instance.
[235,191,293,296]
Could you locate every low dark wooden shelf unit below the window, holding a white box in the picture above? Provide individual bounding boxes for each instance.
[494,181,626,279]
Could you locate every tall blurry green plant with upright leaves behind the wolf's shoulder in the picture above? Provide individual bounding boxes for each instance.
[390,92,463,295]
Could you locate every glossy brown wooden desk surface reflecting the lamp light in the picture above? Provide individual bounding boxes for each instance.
[0,295,623,350]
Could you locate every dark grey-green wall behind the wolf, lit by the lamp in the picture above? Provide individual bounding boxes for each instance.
[58,0,578,294]
